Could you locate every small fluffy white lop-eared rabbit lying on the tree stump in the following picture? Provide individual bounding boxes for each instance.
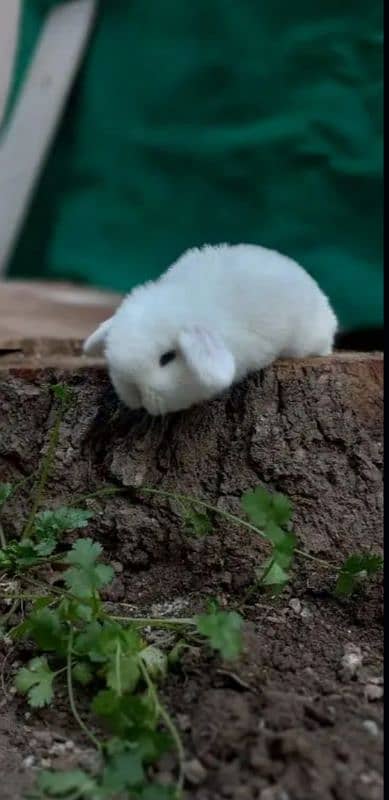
[84,244,337,415]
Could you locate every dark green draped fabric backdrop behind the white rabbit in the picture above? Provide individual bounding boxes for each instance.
[6,0,383,328]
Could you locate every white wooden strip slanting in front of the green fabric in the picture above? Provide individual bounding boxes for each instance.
[0,0,97,276]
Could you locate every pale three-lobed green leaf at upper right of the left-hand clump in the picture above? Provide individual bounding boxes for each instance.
[63,538,114,599]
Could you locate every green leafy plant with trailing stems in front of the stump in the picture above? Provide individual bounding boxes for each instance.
[0,385,383,800]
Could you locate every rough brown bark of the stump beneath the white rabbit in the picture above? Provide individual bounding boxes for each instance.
[0,342,383,600]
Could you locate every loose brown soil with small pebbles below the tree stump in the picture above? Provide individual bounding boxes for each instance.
[0,540,383,800]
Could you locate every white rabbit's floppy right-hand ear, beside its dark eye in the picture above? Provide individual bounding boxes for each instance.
[178,327,235,391]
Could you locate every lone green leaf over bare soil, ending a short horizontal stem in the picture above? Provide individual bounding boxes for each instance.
[195,607,243,661]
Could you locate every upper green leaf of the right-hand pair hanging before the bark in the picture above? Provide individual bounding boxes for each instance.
[241,486,292,530]
